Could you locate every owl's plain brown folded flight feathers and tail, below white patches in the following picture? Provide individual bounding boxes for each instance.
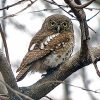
[16,49,50,81]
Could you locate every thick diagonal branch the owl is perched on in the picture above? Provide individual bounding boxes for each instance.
[20,46,100,100]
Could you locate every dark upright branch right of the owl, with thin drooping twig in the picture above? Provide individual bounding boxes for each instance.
[64,0,100,76]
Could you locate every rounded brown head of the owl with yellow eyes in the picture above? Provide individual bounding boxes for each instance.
[42,14,73,33]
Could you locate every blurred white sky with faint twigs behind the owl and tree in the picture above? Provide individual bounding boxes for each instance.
[0,0,100,100]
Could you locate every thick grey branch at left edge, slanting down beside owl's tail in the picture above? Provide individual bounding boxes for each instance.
[0,50,18,95]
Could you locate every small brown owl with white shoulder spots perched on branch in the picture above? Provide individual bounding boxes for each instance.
[16,14,74,81]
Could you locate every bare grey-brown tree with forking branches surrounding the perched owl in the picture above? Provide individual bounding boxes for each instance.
[0,0,100,100]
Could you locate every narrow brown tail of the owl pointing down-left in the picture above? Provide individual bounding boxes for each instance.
[16,67,30,82]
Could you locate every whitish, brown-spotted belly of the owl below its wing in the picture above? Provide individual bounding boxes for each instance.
[44,46,72,68]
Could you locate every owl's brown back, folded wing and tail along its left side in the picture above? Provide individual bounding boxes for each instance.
[16,30,50,81]
